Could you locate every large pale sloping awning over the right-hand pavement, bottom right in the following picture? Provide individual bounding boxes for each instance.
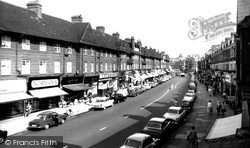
[205,114,242,142]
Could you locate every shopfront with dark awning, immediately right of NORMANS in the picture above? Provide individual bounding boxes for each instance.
[61,76,92,103]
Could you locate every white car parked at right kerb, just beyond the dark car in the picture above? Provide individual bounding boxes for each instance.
[163,106,187,125]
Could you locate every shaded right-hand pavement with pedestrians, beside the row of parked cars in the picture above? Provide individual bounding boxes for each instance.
[162,83,243,148]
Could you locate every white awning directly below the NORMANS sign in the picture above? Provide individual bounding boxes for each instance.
[30,87,68,99]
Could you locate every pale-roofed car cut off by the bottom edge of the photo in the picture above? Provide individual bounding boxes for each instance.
[120,133,160,148]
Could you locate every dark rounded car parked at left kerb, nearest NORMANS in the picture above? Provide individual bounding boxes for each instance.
[28,111,68,129]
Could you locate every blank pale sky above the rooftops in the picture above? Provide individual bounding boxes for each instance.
[2,0,237,58]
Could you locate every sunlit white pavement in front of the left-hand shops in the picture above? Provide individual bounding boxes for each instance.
[0,103,92,136]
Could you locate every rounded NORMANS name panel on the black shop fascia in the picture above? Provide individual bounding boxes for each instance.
[31,79,59,88]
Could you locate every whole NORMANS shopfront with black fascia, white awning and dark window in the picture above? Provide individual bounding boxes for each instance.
[28,76,68,110]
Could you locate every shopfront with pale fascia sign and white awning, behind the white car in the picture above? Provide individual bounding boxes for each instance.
[98,72,119,96]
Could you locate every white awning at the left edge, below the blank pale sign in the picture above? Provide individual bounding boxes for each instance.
[0,92,34,103]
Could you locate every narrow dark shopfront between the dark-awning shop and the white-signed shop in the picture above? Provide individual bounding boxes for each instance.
[84,74,99,97]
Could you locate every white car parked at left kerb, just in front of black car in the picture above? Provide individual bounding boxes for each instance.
[92,97,114,110]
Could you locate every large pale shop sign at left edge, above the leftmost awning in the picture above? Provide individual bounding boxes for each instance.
[0,79,27,95]
